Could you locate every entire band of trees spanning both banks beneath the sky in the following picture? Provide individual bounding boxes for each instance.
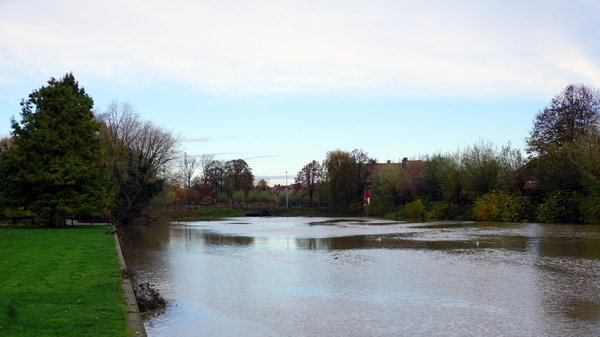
[0,74,600,226]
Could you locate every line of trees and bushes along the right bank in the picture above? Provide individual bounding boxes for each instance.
[276,84,600,223]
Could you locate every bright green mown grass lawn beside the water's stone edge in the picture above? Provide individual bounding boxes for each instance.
[0,226,131,336]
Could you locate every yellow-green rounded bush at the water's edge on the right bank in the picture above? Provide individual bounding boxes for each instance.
[473,190,529,221]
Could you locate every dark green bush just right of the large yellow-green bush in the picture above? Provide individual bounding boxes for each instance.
[536,190,583,223]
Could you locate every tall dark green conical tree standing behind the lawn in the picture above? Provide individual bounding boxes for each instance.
[0,74,109,226]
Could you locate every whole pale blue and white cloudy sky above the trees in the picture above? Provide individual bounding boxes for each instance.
[0,0,600,184]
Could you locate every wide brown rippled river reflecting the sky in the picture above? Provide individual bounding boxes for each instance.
[123,217,600,337]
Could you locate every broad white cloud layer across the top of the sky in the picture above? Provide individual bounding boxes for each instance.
[0,0,600,98]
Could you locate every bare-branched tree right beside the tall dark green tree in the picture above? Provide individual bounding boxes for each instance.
[96,101,179,226]
